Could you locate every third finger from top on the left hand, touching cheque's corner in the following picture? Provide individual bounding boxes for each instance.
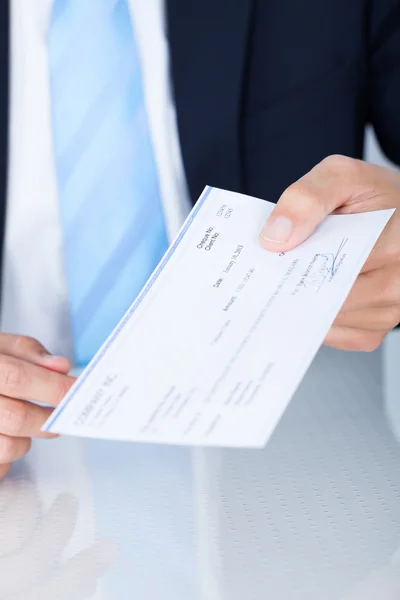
[0,396,56,439]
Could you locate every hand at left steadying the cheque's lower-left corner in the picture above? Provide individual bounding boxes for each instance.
[0,334,74,478]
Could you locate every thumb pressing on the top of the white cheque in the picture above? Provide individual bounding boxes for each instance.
[260,156,366,252]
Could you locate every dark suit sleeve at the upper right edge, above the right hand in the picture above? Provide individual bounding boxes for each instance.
[367,0,400,165]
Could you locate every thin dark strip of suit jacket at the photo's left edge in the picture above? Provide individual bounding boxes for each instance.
[0,0,10,267]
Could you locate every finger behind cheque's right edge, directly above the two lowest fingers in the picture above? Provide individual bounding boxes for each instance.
[342,267,400,312]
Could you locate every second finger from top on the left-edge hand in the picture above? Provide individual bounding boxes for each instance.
[0,355,74,406]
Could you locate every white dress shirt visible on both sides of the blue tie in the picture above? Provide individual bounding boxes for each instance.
[1,0,189,358]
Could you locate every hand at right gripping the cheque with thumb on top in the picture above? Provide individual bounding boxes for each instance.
[260,156,400,351]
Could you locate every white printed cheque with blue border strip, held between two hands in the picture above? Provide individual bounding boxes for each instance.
[44,188,393,448]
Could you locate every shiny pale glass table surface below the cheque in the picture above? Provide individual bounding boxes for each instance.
[0,336,400,600]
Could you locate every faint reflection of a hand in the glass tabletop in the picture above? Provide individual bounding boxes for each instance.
[0,478,116,600]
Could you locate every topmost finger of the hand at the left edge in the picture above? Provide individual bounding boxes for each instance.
[0,333,71,374]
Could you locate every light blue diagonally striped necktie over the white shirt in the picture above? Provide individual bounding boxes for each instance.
[49,0,168,366]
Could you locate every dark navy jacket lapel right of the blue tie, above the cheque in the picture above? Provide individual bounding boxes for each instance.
[167,0,253,201]
